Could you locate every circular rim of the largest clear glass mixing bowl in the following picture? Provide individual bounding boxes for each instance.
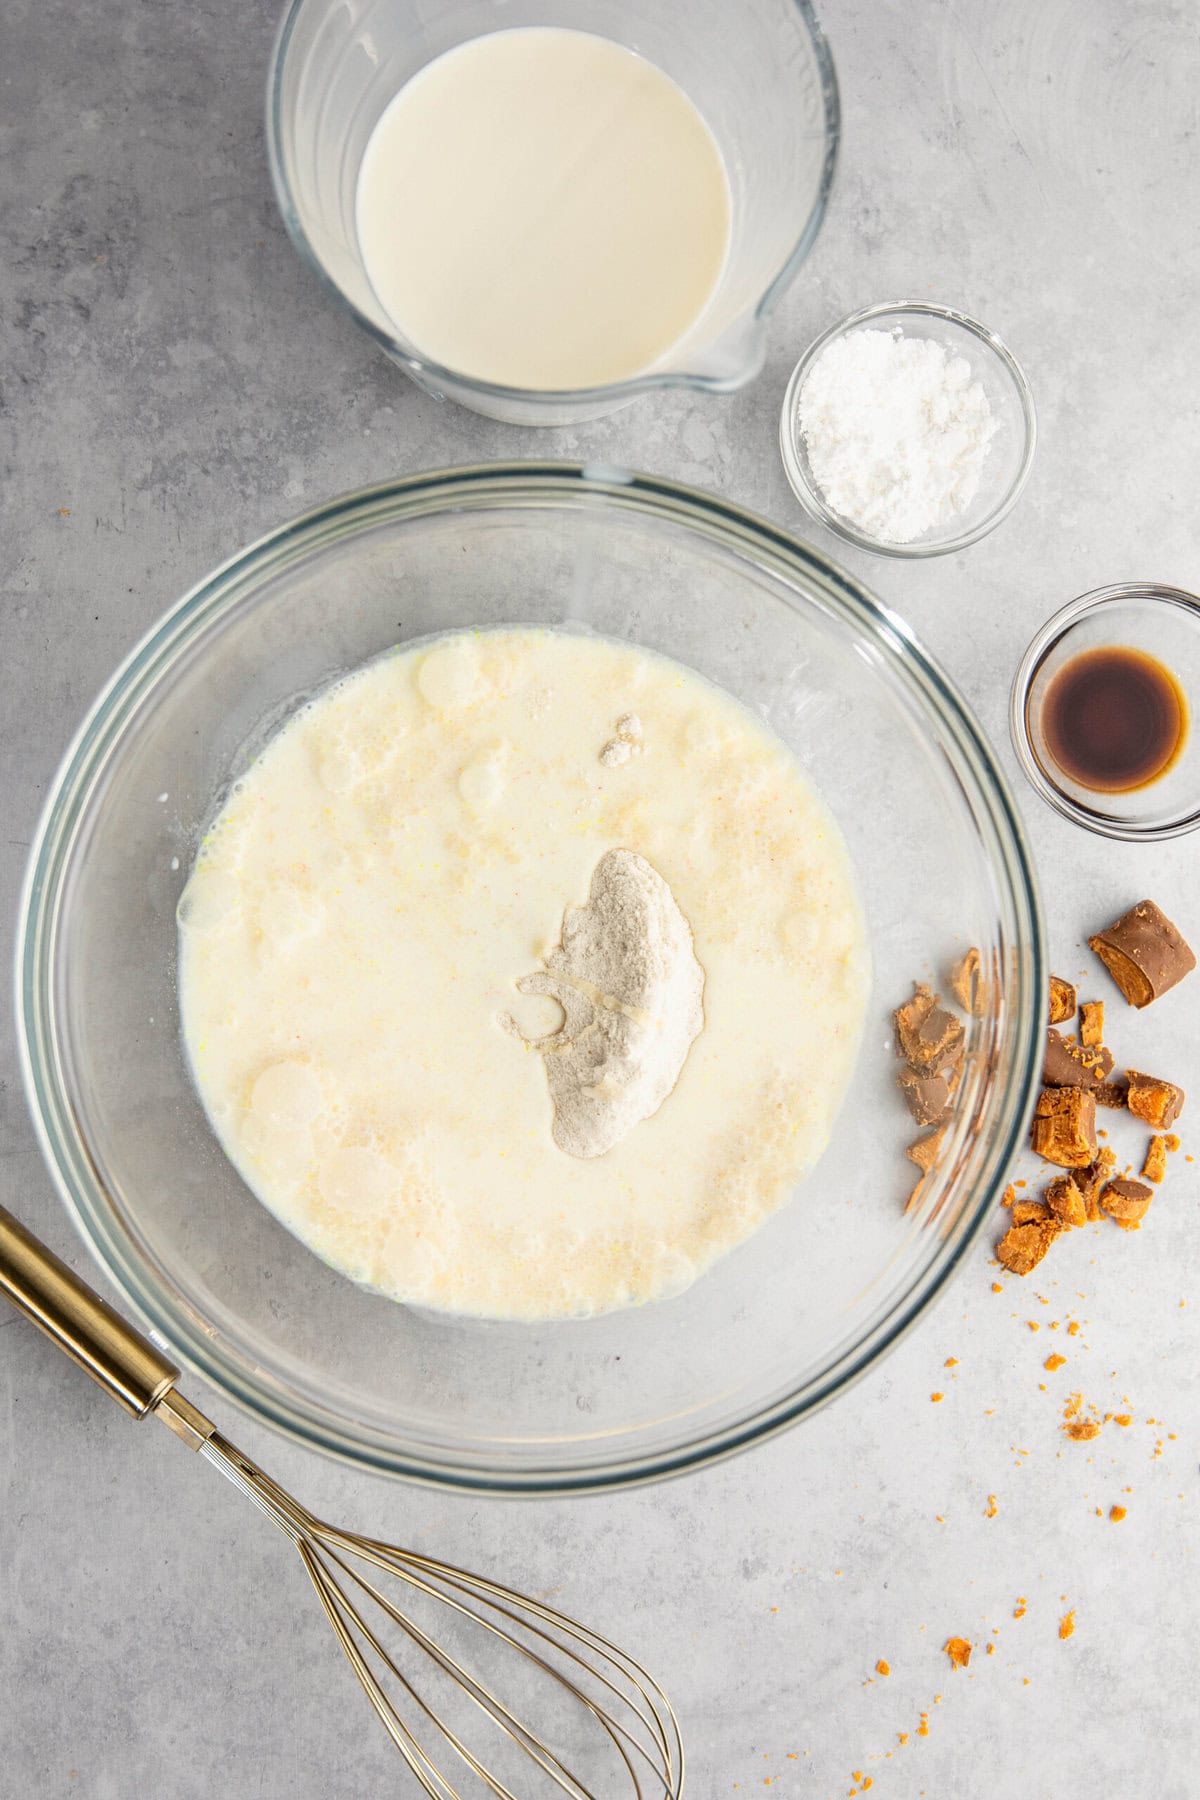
[16,463,1045,1494]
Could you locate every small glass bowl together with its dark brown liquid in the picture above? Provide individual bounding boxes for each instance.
[1011,581,1200,841]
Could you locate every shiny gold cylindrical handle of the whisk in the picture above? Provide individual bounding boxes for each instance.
[0,1206,180,1418]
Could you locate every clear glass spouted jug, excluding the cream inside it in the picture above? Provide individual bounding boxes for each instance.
[266,0,838,425]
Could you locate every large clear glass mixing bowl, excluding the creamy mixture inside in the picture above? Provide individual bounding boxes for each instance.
[18,463,1045,1492]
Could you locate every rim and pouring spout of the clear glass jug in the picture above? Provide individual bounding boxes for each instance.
[266,0,842,407]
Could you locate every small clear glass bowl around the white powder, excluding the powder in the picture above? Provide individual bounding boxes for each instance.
[779,301,1038,556]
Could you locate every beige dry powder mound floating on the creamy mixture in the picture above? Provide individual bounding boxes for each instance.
[518,850,703,1157]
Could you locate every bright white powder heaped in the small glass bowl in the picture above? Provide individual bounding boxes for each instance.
[797,329,999,544]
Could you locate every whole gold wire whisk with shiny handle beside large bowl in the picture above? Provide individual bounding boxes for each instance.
[0,1206,684,1800]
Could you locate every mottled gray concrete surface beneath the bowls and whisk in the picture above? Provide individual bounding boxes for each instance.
[0,0,1200,1800]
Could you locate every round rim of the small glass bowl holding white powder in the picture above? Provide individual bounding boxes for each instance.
[779,301,1038,556]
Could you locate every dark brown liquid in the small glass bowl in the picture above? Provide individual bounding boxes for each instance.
[1038,644,1187,794]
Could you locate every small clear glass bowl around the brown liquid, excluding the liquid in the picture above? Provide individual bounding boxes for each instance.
[1009,581,1200,841]
